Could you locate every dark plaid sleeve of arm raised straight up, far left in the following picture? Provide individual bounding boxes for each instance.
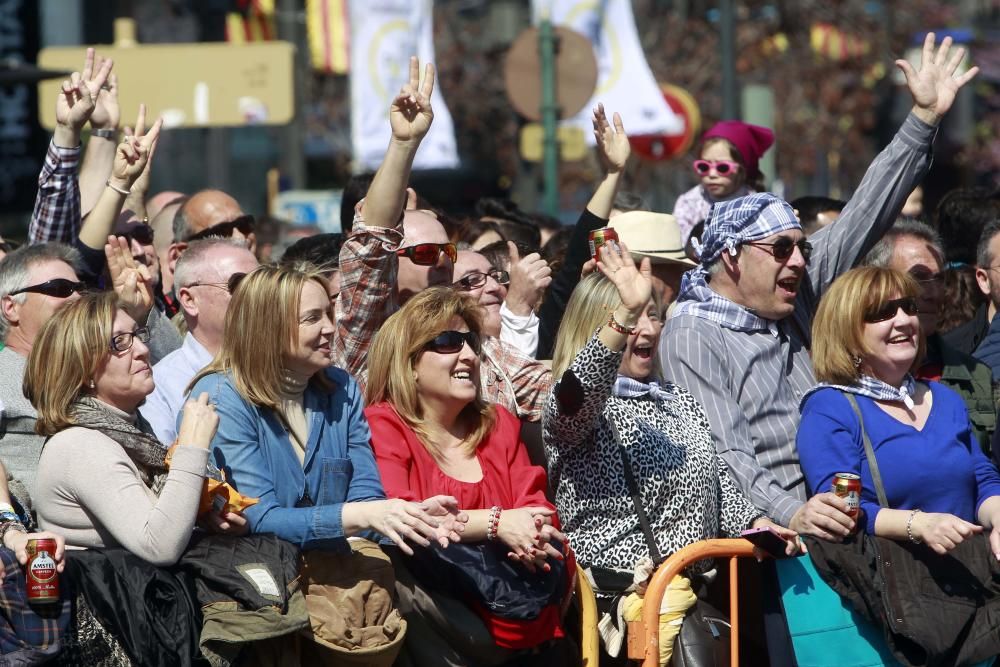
[28,139,81,244]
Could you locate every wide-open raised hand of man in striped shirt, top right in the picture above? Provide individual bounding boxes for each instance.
[896,32,979,125]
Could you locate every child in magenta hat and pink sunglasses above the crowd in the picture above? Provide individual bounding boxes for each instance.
[674,120,774,241]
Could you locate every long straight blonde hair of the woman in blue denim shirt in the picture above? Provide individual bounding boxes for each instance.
[187,266,332,416]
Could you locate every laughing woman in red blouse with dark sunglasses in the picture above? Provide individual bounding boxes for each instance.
[365,287,575,666]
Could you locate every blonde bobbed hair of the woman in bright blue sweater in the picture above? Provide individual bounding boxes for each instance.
[812,266,926,385]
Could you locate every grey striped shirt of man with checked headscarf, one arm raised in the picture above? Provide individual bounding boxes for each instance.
[660,114,936,526]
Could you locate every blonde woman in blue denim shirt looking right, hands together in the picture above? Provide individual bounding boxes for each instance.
[192,267,465,553]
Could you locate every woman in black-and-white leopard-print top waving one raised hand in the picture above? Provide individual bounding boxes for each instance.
[542,244,797,664]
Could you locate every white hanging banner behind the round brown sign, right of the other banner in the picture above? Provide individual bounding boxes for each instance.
[531,0,684,145]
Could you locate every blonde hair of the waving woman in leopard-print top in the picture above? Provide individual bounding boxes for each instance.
[552,273,663,379]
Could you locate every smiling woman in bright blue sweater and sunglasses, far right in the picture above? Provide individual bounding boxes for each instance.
[796,267,1000,557]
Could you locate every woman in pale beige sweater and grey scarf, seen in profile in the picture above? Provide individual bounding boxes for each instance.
[24,292,218,565]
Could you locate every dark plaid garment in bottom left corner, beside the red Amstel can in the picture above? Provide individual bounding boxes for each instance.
[0,547,70,665]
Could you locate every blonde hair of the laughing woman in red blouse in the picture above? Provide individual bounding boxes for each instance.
[365,287,496,457]
